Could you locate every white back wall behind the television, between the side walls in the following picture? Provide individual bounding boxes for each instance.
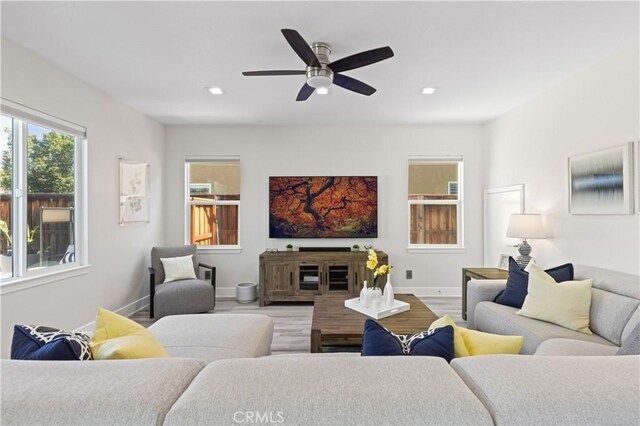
[165,126,482,296]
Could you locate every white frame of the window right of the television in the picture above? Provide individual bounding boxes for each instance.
[406,155,466,253]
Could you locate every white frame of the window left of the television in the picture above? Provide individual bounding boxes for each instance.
[184,155,242,253]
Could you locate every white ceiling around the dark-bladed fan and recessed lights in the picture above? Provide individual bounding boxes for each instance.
[1,1,639,125]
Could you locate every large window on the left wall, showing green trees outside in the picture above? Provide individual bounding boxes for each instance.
[0,100,85,283]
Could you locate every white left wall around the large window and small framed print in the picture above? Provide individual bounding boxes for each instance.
[1,39,164,357]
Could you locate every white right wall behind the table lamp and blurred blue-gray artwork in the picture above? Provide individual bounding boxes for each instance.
[483,45,640,274]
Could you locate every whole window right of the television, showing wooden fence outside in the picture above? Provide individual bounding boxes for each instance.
[408,157,463,248]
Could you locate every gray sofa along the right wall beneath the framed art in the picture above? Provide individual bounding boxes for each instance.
[467,265,640,354]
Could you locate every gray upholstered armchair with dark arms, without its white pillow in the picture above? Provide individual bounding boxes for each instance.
[149,245,216,319]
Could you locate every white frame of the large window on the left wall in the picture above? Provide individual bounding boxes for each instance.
[0,98,90,294]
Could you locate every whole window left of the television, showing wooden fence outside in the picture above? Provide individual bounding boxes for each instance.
[185,158,240,249]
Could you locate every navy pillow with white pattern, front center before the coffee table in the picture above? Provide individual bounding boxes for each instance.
[362,319,453,362]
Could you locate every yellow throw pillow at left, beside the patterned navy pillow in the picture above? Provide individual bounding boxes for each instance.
[89,308,169,359]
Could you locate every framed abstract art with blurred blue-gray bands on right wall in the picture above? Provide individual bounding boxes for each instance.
[569,142,634,214]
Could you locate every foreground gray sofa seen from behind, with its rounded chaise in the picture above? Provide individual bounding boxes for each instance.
[0,268,640,425]
